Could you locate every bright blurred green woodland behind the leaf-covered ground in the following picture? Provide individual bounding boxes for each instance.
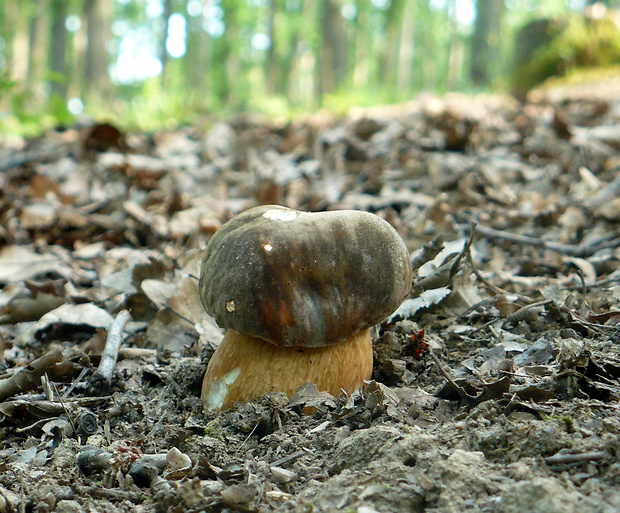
[0,0,620,130]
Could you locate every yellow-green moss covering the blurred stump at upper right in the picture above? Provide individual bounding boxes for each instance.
[513,15,620,91]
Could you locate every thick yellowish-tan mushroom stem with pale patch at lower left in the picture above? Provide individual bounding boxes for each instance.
[201,329,372,411]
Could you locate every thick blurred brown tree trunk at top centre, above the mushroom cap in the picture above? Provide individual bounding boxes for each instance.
[319,0,347,97]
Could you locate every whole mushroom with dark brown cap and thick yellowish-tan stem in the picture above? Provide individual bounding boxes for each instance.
[199,205,412,410]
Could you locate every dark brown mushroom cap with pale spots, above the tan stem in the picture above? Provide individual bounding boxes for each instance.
[199,206,412,347]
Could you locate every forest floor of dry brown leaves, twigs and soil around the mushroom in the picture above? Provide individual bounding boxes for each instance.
[0,79,620,513]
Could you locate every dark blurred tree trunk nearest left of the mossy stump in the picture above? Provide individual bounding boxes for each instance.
[470,0,505,87]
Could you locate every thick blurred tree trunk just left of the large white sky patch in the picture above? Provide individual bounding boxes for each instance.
[83,0,114,101]
